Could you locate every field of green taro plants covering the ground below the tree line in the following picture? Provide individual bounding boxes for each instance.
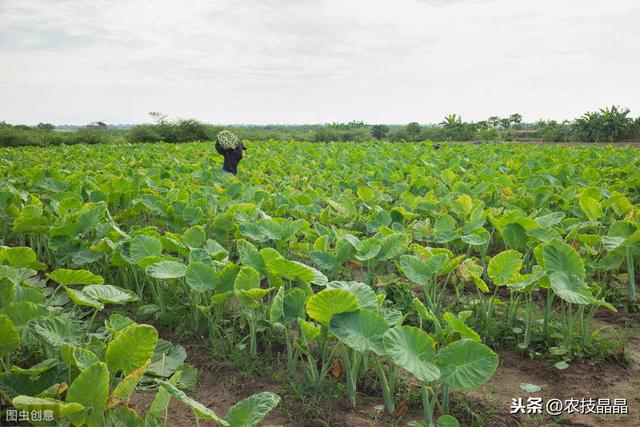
[0,141,640,427]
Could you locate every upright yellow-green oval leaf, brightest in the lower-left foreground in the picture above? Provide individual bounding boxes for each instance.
[105,324,158,375]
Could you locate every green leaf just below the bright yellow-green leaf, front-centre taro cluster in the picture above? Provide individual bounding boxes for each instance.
[330,310,389,356]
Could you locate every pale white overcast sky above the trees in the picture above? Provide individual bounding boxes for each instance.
[0,0,640,124]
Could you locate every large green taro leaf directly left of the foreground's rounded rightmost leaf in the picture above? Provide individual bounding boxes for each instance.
[383,326,440,383]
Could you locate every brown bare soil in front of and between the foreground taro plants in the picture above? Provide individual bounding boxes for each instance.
[132,319,640,427]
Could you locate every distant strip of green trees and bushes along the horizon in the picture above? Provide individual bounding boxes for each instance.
[0,106,640,147]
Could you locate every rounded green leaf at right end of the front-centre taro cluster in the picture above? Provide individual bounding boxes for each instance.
[437,339,498,390]
